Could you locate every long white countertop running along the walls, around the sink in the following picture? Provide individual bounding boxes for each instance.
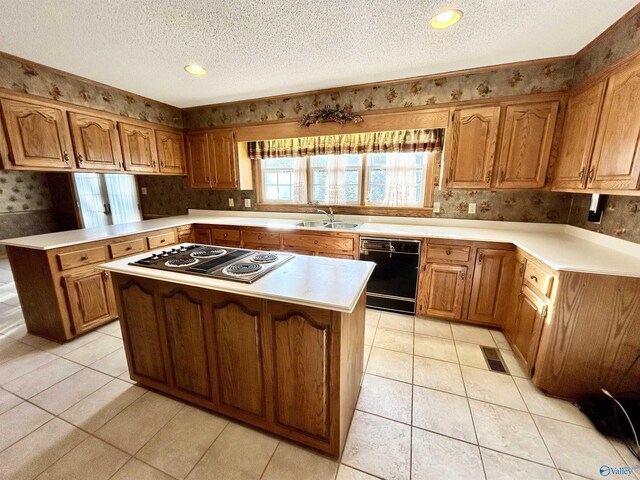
[5,210,640,277]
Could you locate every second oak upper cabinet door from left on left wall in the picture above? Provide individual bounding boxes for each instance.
[69,112,122,170]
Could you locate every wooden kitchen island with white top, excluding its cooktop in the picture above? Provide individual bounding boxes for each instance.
[99,246,374,455]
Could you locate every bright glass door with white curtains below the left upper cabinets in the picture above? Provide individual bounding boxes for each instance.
[73,173,142,228]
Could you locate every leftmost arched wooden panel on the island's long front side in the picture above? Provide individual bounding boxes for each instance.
[116,280,169,386]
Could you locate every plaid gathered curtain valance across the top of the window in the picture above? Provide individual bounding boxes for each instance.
[249,129,443,159]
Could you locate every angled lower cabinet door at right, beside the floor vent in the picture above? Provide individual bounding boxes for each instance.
[512,287,547,372]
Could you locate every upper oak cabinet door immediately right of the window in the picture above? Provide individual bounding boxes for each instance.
[445,107,500,189]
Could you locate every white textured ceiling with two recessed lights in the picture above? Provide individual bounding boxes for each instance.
[0,0,636,107]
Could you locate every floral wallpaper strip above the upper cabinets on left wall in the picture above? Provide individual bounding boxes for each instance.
[0,52,182,127]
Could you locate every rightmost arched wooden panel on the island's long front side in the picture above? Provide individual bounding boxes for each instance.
[268,302,337,439]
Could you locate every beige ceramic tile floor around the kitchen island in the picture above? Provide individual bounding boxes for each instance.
[0,259,632,480]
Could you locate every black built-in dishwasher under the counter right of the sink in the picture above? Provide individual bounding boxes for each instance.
[360,237,421,314]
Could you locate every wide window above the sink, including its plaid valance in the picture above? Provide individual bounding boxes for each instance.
[249,129,443,208]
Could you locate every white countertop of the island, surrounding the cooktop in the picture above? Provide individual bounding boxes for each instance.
[98,244,375,313]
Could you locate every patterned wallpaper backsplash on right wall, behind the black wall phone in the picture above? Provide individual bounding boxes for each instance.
[568,194,640,243]
